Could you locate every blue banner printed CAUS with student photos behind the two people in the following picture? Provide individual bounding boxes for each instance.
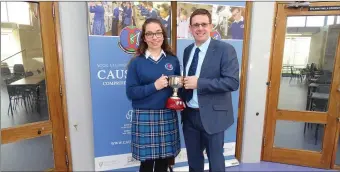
[88,1,245,171]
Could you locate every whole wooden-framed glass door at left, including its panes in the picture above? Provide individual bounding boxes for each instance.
[1,2,67,171]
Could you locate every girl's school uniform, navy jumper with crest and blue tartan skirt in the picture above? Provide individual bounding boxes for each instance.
[126,51,181,162]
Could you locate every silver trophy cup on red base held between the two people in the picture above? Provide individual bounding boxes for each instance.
[166,75,184,110]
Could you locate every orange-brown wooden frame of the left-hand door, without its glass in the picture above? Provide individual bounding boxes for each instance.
[1,2,72,171]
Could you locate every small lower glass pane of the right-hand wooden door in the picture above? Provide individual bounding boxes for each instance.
[274,120,326,152]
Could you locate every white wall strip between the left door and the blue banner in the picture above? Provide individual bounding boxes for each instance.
[59,2,94,171]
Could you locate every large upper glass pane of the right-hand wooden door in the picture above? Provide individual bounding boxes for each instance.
[278,16,340,112]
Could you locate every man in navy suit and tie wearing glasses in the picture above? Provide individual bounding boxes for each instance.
[181,9,239,172]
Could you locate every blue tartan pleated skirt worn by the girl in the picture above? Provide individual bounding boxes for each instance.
[131,109,181,161]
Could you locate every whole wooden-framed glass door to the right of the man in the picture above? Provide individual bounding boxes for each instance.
[263,2,340,168]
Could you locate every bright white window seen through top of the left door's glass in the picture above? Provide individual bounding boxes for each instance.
[7,2,31,25]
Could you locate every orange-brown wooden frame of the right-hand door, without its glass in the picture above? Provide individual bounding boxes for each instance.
[262,2,340,169]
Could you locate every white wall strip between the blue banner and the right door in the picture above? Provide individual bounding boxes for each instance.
[241,2,275,163]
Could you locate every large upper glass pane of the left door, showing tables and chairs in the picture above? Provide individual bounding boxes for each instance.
[1,2,49,128]
